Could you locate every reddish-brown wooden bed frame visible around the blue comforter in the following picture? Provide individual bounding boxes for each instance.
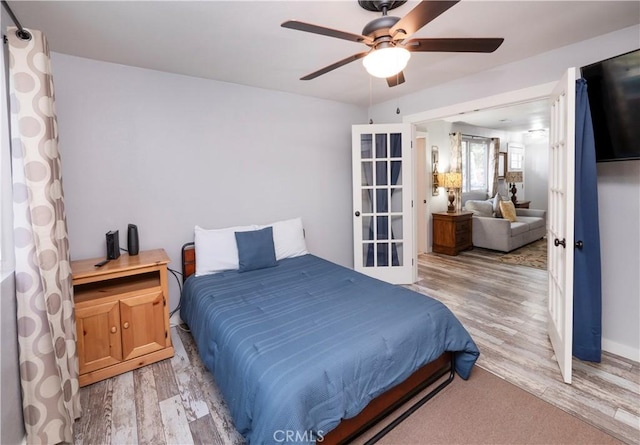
[182,242,455,445]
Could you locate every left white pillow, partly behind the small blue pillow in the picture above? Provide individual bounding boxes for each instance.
[194,225,256,277]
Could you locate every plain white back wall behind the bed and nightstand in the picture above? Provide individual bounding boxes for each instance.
[52,53,366,308]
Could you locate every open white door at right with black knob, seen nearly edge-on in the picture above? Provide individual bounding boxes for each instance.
[547,68,576,383]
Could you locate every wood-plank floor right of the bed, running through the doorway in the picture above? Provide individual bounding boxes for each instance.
[409,248,640,443]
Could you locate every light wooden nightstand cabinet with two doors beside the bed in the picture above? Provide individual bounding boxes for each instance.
[71,249,173,386]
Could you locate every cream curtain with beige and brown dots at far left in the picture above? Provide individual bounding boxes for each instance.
[7,28,80,444]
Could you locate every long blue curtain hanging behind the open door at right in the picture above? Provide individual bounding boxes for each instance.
[573,79,602,362]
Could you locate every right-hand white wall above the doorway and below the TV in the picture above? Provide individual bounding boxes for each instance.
[370,25,640,361]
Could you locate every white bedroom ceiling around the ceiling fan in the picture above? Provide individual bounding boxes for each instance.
[9,0,640,119]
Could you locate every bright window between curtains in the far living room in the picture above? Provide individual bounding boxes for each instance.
[462,135,491,192]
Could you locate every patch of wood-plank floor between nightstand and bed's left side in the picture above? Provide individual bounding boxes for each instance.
[75,327,244,445]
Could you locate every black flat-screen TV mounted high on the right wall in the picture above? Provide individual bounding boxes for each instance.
[581,49,640,162]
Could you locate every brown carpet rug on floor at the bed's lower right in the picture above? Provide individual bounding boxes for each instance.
[356,366,622,445]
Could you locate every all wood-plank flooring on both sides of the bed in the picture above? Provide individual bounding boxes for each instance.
[75,249,640,445]
